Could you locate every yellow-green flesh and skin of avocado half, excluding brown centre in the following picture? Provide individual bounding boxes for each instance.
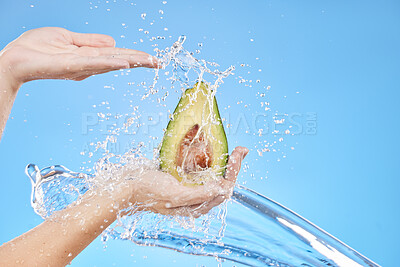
[160,82,228,184]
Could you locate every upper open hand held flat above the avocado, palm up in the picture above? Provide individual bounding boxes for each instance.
[0,28,157,85]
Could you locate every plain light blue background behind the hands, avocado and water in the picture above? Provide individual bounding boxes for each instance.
[0,0,400,266]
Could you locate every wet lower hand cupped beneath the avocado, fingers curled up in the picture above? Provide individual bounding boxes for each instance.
[126,147,249,217]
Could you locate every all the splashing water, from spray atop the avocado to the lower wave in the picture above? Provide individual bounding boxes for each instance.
[26,36,378,266]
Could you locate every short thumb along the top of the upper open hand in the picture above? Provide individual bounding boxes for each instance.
[71,32,115,47]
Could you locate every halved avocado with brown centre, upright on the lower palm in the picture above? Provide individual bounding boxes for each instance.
[160,82,228,184]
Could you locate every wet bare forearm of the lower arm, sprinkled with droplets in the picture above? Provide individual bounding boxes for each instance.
[0,184,134,266]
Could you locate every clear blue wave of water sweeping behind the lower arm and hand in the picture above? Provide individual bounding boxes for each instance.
[26,164,379,267]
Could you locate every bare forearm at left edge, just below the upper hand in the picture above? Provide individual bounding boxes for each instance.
[0,55,21,140]
